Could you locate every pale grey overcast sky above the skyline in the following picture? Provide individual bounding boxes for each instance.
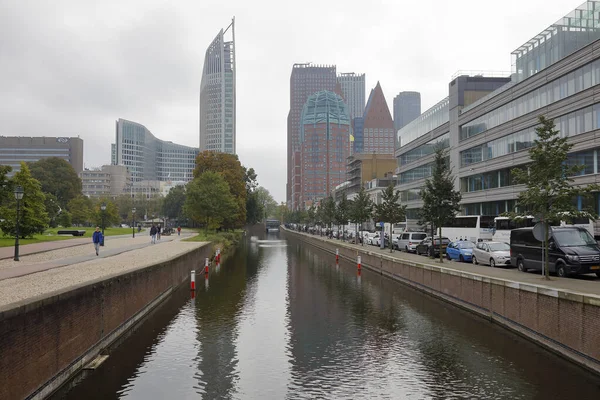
[0,0,582,201]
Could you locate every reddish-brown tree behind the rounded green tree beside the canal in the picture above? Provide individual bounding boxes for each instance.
[194,151,246,227]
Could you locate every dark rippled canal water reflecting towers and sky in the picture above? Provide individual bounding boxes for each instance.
[54,233,600,400]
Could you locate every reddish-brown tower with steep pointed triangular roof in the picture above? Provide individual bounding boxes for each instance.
[354,82,396,154]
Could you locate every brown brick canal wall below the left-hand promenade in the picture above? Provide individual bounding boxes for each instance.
[0,244,211,399]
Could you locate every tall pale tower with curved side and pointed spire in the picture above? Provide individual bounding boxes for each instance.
[200,19,236,154]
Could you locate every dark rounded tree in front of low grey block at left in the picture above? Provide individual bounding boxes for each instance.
[29,157,81,208]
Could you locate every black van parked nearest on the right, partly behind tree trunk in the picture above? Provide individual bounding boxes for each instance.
[510,226,600,277]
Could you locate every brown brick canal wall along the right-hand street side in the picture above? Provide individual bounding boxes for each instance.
[286,231,600,379]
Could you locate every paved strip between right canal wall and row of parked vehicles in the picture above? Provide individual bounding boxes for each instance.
[294,232,600,296]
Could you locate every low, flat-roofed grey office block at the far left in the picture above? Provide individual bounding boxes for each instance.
[0,136,83,176]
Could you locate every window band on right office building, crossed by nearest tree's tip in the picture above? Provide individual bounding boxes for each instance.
[460,103,600,167]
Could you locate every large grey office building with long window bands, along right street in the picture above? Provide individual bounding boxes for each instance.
[396,1,600,223]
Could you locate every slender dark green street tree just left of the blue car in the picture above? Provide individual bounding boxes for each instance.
[419,147,462,263]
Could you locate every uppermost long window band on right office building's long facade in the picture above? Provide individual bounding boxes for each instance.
[459,60,600,141]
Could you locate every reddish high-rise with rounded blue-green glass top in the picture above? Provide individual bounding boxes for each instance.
[294,90,350,208]
